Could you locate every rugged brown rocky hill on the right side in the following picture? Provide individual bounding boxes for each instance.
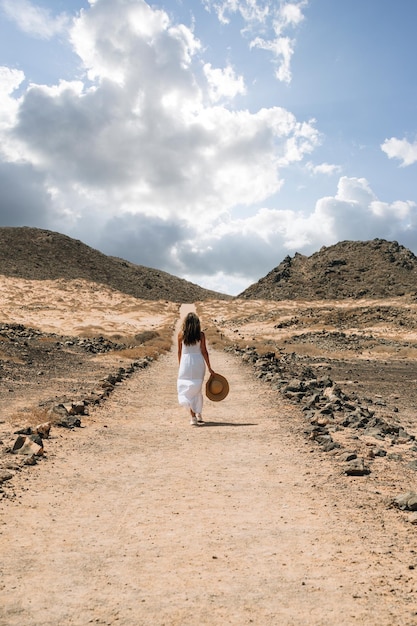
[237,239,417,300]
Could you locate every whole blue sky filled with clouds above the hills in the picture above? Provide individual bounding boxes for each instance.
[0,0,417,294]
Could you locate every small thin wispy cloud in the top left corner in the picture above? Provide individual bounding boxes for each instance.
[0,0,70,39]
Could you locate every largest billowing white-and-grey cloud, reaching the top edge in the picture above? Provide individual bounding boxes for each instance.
[2,0,320,229]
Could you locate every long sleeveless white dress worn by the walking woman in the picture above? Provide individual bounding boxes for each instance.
[177,341,206,413]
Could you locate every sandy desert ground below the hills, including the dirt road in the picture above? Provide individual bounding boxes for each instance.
[0,278,417,626]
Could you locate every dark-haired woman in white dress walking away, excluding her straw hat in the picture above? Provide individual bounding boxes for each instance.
[177,313,214,426]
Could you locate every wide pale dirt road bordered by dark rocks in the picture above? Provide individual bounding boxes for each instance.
[0,306,417,626]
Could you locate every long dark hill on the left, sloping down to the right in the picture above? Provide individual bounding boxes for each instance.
[0,227,229,302]
